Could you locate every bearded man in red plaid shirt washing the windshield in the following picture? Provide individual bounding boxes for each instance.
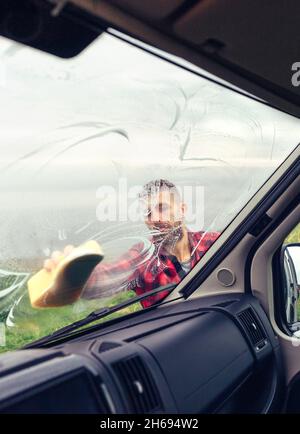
[44,179,219,308]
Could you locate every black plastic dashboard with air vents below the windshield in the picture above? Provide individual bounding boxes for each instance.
[0,294,283,414]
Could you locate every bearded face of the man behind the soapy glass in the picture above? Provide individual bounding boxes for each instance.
[143,190,185,242]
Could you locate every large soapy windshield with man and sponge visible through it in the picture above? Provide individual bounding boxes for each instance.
[0,34,300,350]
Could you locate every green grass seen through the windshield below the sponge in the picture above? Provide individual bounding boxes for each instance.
[0,291,141,352]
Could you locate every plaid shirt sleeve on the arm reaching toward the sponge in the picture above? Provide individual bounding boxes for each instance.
[81,245,141,299]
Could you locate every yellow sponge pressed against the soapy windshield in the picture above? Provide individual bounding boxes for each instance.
[27,240,104,307]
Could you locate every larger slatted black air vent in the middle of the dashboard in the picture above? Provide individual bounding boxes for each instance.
[113,356,163,414]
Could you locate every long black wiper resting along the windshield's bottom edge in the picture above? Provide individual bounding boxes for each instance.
[24,283,177,348]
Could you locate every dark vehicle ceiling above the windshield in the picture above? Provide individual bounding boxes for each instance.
[0,0,300,117]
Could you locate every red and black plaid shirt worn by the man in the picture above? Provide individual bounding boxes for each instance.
[82,232,219,308]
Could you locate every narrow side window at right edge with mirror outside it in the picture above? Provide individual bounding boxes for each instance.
[281,223,300,325]
